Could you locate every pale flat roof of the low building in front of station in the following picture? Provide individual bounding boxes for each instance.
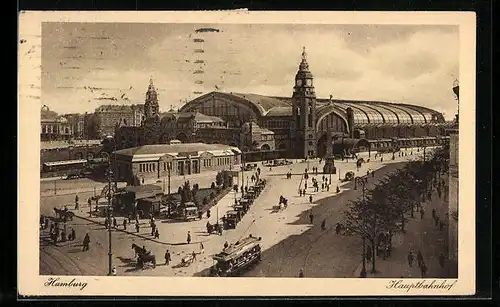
[115,143,239,162]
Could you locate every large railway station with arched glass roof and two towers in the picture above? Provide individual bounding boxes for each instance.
[115,49,450,158]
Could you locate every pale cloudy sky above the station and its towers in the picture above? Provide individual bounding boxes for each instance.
[41,23,459,119]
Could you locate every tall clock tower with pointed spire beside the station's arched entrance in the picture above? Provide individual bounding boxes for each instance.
[292,47,317,158]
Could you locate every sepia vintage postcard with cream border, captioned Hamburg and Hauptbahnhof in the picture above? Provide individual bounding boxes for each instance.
[18,11,476,297]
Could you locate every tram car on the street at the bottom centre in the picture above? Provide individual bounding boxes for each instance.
[210,235,262,277]
